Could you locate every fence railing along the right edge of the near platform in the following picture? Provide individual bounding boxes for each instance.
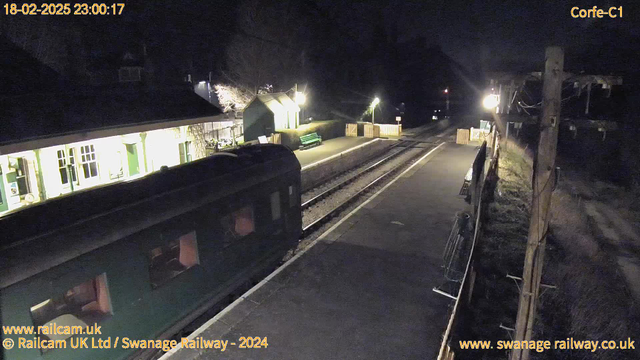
[438,127,500,360]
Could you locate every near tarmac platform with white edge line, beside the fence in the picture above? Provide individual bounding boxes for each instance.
[162,143,477,360]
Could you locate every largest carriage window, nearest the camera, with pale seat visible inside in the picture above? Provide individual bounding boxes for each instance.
[31,273,112,340]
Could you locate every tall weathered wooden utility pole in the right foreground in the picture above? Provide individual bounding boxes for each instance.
[510,47,564,360]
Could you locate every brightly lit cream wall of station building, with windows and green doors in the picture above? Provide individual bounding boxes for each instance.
[0,125,215,216]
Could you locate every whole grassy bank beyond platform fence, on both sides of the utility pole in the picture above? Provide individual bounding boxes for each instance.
[456,140,640,360]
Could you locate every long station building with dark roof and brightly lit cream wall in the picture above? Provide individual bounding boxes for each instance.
[0,88,225,216]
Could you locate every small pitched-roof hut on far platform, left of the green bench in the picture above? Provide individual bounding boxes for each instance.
[243,93,300,141]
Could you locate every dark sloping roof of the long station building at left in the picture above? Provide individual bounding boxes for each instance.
[0,88,222,153]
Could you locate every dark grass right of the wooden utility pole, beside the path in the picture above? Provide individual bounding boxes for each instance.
[537,172,640,360]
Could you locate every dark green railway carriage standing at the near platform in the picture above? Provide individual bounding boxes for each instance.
[0,145,302,360]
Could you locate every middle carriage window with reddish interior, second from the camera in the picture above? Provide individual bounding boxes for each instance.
[149,231,200,289]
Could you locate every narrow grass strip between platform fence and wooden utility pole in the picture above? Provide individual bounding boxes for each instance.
[456,142,532,359]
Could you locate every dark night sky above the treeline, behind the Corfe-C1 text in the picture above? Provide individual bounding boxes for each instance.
[320,0,640,69]
